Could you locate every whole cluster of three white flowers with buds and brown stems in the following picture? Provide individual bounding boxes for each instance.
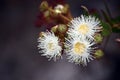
[38,0,103,65]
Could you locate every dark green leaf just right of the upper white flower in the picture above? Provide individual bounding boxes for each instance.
[101,22,112,36]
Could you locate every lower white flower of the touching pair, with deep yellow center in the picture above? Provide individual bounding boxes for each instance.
[65,36,95,65]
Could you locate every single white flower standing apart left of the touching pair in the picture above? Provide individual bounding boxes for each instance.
[38,32,62,61]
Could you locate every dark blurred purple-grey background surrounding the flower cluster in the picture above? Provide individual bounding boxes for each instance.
[0,0,120,80]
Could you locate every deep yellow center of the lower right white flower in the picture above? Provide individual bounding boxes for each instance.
[73,42,85,55]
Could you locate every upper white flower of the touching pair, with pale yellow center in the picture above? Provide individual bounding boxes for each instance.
[67,15,101,38]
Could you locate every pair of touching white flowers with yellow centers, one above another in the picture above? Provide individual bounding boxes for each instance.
[65,15,101,65]
